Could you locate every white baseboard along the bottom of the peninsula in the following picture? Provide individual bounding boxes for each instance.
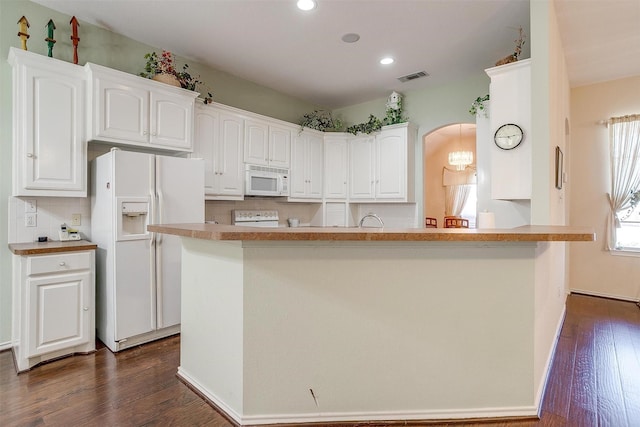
[178,367,538,425]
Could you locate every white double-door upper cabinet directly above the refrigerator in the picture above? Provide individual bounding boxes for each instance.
[85,64,198,151]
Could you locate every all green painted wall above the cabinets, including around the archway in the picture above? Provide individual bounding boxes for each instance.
[0,0,496,346]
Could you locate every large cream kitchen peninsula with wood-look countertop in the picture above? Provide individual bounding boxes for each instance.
[149,224,595,424]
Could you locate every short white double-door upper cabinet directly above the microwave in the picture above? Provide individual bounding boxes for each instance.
[244,119,292,169]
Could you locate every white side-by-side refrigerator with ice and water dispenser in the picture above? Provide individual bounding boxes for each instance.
[91,148,204,352]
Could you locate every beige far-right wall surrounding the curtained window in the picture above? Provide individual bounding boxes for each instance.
[569,76,640,300]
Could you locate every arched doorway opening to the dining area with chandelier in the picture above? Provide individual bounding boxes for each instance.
[422,123,477,227]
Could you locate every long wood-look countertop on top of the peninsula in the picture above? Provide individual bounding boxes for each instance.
[148,223,596,242]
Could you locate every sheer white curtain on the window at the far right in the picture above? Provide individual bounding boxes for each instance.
[606,114,640,250]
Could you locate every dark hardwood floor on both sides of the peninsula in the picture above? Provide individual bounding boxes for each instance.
[0,295,640,427]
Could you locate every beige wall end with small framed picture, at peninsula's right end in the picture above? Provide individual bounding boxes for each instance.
[531,1,571,399]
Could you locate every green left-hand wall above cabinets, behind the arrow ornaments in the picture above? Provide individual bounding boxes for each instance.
[0,0,319,347]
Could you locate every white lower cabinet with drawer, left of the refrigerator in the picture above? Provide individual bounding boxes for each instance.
[14,250,95,371]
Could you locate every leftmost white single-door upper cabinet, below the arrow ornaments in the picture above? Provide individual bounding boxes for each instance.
[9,48,87,197]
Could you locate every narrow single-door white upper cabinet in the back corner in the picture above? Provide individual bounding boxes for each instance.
[324,134,349,200]
